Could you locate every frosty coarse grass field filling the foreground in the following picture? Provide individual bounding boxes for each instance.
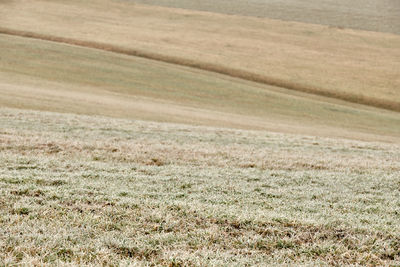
[0,108,400,266]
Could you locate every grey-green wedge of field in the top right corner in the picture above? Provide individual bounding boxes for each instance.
[126,0,400,34]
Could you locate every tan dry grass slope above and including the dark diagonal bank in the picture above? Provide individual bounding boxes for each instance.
[1,0,400,111]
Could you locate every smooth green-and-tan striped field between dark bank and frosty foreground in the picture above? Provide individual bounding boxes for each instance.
[0,35,400,142]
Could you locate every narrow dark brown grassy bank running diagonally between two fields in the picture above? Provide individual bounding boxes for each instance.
[0,27,400,112]
